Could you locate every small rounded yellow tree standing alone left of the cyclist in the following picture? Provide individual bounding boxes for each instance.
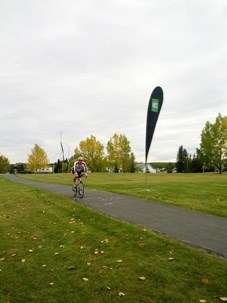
[27,144,48,172]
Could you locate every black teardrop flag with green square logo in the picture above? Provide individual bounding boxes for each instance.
[145,86,163,163]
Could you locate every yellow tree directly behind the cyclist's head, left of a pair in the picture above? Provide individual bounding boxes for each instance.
[75,135,105,172]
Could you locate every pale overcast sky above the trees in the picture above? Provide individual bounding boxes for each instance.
[0,0,227,163]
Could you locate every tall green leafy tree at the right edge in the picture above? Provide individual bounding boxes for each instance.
[200,113,227,174]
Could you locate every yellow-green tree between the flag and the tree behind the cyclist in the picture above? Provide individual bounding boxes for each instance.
[107,133,132,172]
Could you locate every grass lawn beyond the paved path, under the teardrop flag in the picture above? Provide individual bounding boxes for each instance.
[18,173,227,217]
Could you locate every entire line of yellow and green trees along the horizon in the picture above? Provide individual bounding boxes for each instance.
[0,113,227,173]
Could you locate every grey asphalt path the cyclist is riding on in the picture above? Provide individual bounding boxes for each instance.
[5,174,227,258]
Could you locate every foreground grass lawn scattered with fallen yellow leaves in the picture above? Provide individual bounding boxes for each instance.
[0,174,227,303]
